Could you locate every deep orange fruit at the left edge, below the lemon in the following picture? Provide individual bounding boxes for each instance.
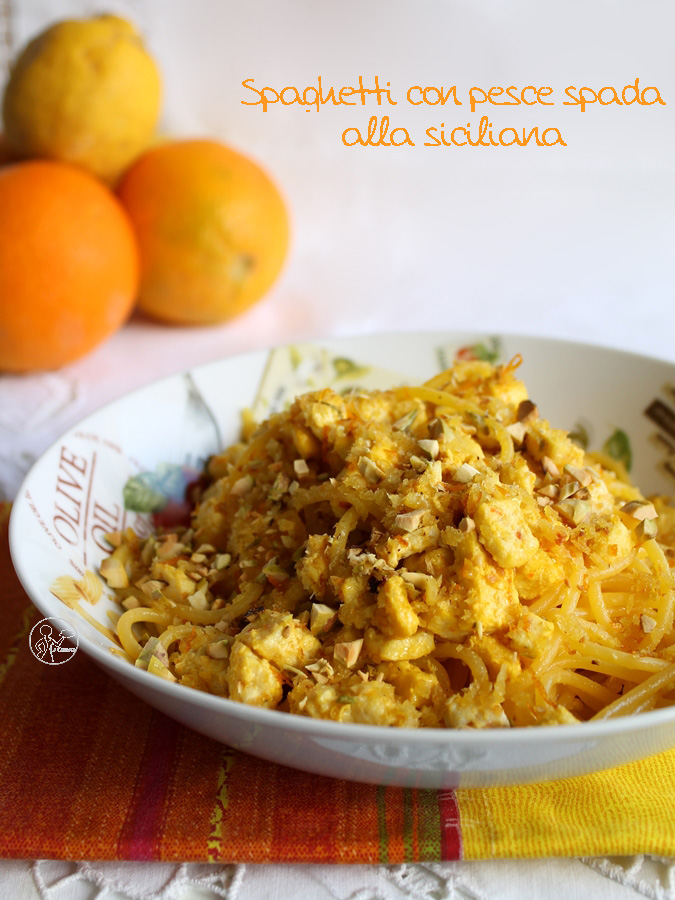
[0,161,138,372]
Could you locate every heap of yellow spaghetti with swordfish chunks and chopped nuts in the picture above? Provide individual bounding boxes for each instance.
[101,359,675,728]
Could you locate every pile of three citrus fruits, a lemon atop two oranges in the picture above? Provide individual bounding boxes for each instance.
[0,15,289,372]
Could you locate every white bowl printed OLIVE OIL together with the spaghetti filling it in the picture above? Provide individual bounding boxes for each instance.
[10,334,675,787]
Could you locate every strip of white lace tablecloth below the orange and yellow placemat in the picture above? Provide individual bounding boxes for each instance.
[0,857,674,900]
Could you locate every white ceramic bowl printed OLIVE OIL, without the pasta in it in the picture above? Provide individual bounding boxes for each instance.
[10,334,675,788]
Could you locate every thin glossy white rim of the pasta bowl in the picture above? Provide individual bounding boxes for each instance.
[9,330,675,747]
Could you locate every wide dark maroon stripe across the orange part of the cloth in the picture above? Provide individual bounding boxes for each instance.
[118,712,182,860]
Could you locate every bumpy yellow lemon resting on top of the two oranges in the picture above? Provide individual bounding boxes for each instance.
[3,15,161,183]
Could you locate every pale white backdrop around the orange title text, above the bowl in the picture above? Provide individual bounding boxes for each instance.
[5,0,675,364]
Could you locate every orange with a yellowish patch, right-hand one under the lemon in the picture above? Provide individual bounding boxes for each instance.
[118,140,289,324]
